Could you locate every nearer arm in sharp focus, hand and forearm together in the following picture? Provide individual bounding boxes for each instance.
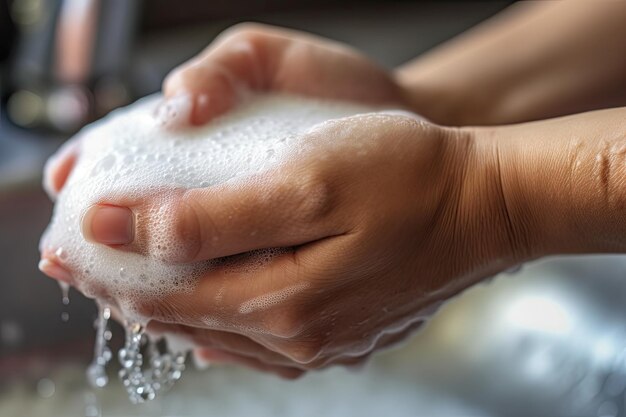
[69,108,626,375]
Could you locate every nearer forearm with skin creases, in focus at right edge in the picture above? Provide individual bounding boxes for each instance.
[472,107,626,257]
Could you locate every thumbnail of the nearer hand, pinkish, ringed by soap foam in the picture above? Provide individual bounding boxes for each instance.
[81,205,135,245]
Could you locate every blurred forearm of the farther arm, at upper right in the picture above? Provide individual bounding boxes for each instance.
[396,0,626,125]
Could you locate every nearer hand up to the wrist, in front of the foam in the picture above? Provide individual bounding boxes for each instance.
[69,114,526,376]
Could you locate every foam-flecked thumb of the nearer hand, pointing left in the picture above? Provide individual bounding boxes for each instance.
[81,169,345,263]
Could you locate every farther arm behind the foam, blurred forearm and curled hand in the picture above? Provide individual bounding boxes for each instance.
[45,10,626,196]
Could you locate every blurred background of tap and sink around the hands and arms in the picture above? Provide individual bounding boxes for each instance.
[0,0,626,417]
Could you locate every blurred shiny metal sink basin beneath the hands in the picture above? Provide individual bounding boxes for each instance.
[0,256,626,417]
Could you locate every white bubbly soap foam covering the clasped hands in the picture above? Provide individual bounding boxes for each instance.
[42,95,380,400]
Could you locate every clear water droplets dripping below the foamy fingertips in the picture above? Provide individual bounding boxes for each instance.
[87,306,185,404]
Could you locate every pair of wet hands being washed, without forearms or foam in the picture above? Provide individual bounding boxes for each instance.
[44,25,529,377]
